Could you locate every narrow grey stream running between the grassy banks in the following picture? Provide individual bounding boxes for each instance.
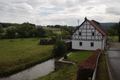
[0,59,55,80]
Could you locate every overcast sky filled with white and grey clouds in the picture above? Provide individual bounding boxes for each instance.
[0,0,120,26]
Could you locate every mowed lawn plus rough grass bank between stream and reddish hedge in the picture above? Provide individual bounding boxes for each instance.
[36,51,93,80]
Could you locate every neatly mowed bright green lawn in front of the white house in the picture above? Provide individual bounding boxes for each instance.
[64,51,94,61]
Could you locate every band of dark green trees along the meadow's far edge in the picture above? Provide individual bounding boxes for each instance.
[0,22,73,39]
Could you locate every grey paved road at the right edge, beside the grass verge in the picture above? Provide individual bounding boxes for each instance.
[107,40,120,80]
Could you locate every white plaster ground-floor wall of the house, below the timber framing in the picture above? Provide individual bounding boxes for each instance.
[72,40,101,50]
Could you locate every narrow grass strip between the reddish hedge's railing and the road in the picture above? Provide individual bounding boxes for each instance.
[96,54,109,80]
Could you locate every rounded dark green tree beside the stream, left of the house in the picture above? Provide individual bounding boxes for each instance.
[53,40,67,56]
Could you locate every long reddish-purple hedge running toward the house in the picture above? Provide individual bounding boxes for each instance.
[77,49,100,80]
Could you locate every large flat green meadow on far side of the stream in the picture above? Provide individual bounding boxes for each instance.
[0,38,53,76]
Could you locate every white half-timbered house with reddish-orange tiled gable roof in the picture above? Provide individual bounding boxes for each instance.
[72,18,107,50]
